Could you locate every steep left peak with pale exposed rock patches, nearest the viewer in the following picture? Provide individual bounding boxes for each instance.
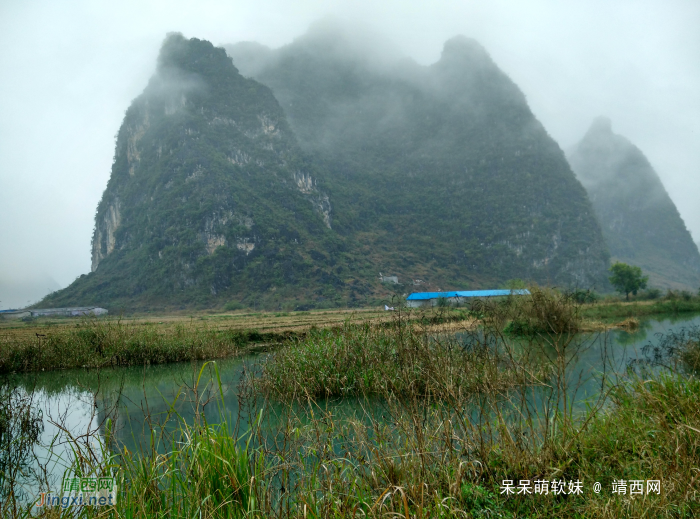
[42,34,362,307]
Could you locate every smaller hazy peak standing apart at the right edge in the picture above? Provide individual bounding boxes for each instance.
[568,118,700,290]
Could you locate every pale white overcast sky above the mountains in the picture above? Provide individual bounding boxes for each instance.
[0,0,700,308]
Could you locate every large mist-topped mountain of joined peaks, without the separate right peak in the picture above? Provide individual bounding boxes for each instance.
[41,24,608,309]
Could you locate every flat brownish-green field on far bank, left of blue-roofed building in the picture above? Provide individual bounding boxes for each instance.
[0,309,468,374]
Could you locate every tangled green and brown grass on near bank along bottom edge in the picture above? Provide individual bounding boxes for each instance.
[19,364,700,519]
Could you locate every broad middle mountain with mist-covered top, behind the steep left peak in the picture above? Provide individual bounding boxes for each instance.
[226,21,608,288]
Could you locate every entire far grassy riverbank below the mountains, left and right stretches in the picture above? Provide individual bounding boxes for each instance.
[0,296,700,373]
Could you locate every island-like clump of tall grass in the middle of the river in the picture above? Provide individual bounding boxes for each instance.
[253,313,546,400]
